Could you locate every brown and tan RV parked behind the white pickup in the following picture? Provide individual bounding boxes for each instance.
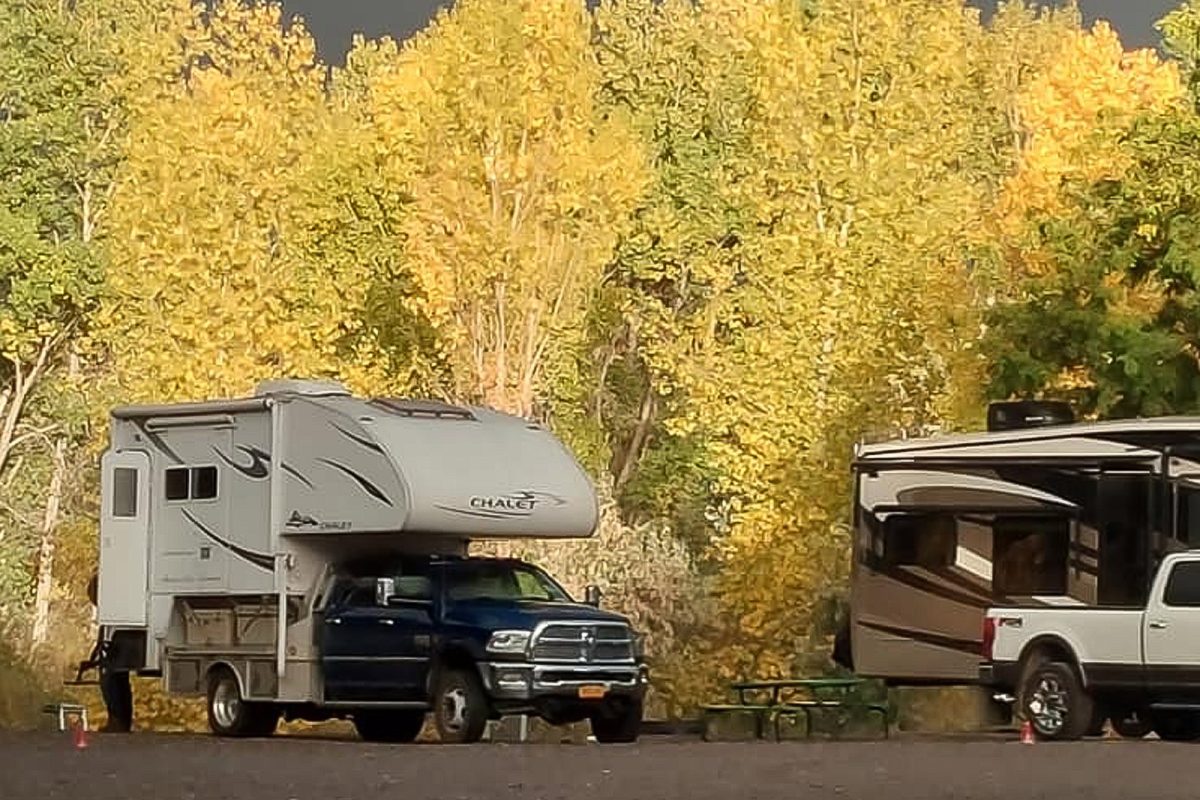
[835,403,1200,685]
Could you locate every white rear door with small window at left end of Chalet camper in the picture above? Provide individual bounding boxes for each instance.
[97,450,150,626]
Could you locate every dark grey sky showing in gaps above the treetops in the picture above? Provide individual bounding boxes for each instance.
[283,0,1180,64]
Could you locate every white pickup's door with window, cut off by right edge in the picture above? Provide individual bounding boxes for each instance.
[1142,554,1200,691]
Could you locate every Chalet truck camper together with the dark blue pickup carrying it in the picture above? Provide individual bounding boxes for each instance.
[82,380,648,742]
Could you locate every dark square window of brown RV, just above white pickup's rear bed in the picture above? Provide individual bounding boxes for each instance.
[991,517,1070,596]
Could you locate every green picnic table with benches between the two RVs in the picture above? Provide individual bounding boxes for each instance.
[701,678,888,741]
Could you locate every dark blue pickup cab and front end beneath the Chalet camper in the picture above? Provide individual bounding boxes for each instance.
[314,557,648,742]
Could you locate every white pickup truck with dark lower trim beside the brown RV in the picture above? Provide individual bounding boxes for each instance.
[979,551,1200,741]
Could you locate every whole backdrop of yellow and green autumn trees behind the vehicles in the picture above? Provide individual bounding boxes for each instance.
[0,0,1200,726]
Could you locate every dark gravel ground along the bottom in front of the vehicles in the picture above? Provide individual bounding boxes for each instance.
[0,733,1200,800]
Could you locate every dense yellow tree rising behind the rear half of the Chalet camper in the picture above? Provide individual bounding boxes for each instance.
[103,2,374,401]
